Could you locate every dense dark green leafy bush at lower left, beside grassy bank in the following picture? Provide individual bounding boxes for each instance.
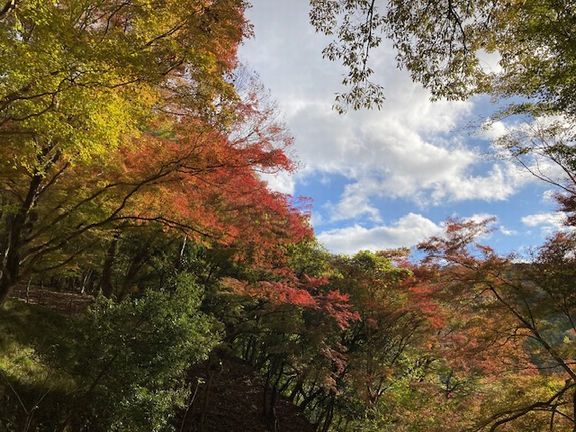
[49,275,219,431]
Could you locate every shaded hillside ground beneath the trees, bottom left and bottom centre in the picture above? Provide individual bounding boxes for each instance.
[0,296,315,432]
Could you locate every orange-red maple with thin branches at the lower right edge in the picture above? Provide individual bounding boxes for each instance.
[421,221,576,431]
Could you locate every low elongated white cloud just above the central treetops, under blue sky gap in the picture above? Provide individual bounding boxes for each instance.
[318,213,442,254]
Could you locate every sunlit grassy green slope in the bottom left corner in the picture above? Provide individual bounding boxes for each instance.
[0,301,77,431]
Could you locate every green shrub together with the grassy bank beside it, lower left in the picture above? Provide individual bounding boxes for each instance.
[0,274,221,432]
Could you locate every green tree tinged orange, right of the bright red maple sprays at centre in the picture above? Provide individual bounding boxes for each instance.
[334,250,422,404]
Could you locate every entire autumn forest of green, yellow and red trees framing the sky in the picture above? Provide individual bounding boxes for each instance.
[0,0,576,432]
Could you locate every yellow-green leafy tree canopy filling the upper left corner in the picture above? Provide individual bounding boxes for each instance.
[0,0,248,300]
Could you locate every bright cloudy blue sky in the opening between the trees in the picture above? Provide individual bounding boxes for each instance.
[239,0,561,256]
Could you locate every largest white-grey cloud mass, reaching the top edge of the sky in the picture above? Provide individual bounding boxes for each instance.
[240,0,523,221]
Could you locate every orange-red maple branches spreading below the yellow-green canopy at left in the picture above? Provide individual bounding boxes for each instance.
[0,75,310,304]
